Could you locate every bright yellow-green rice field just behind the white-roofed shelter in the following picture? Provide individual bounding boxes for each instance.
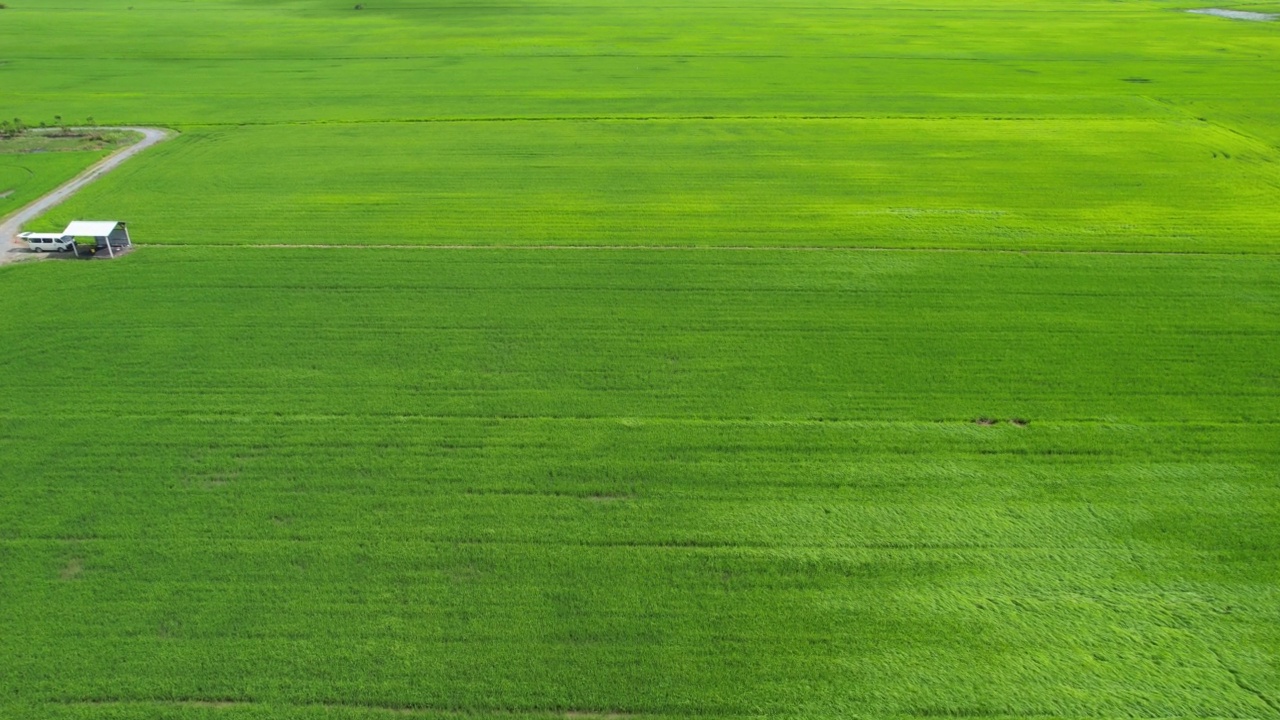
[32,118,1280,252]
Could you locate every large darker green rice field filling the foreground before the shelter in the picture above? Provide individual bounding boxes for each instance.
[0,249,1280,717]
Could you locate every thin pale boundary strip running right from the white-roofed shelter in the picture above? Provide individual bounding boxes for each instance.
[133,242,1280,258]
